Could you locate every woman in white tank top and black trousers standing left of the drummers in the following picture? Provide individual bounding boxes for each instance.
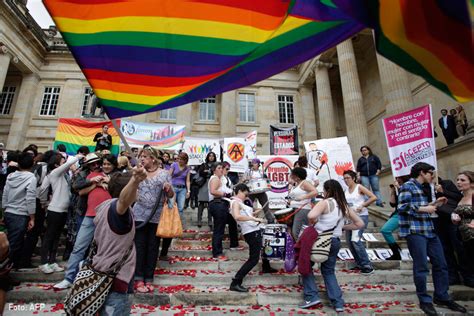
[209,162,239,260]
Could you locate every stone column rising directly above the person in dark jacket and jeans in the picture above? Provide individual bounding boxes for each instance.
[337,39,369,152]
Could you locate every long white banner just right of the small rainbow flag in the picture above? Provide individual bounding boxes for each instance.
[120,120,185,150]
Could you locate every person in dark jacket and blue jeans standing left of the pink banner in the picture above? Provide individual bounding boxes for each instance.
[356,146,384,207]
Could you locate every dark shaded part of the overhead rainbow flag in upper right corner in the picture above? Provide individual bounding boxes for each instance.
[332,0,474,102]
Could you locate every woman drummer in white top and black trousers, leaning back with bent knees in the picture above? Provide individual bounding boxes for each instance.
[230,183,277,292]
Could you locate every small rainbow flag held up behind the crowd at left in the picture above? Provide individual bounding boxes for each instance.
[54,118,120,155]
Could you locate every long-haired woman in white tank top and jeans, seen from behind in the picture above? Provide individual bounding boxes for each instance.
[300,180,364,312]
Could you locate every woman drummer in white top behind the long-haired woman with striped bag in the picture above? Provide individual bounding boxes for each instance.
[288,167,318,240]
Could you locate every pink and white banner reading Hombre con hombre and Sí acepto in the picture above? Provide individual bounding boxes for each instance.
[383,105,438,177]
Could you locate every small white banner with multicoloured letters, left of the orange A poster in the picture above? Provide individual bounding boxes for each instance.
[183,137,221,166]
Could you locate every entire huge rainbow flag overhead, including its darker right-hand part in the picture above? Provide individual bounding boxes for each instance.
[43,0,474,118]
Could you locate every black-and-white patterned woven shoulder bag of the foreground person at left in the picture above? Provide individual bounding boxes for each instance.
[64,240,134,316]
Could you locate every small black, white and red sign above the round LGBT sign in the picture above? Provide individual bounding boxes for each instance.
[270,125,298,155]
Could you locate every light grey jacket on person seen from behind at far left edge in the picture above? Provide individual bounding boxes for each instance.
[2,171,36,216]
